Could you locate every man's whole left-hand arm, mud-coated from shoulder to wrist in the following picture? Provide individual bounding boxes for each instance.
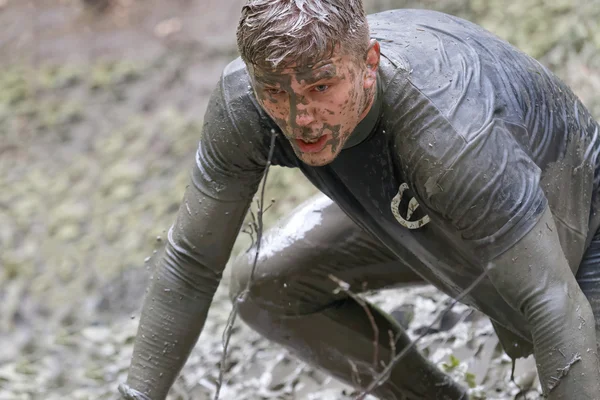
[119,63,269,400]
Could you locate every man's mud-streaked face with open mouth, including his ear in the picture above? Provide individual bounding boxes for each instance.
[251,41,379,166]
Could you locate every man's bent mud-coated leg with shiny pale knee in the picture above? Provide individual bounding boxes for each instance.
[231,196,467,400]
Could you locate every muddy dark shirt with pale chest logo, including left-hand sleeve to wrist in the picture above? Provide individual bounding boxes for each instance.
[120,10,600,399]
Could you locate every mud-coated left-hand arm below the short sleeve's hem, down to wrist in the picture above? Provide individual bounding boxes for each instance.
[122,180,255,400]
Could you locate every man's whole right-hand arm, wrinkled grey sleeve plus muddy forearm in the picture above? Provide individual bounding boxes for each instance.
[395,95,600,400]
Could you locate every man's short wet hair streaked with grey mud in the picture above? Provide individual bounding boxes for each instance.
[237,0,369,69]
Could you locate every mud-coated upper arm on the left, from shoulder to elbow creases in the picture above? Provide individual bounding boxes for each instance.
[170,59,270,272]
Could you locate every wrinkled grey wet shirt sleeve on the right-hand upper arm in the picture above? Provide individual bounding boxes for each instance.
[394,84,547,263]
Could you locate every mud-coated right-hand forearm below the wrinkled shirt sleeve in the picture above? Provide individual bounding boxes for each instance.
[488,208,600,400]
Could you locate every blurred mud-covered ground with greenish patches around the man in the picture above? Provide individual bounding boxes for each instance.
[0,0,600,400]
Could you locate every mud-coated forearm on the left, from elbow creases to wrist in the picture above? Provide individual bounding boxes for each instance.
[121,239,220,400]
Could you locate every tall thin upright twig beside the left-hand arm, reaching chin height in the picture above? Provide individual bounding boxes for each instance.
[214,130,277,400]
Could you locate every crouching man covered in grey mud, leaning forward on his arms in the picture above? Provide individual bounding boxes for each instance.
[120,0,600,400]
